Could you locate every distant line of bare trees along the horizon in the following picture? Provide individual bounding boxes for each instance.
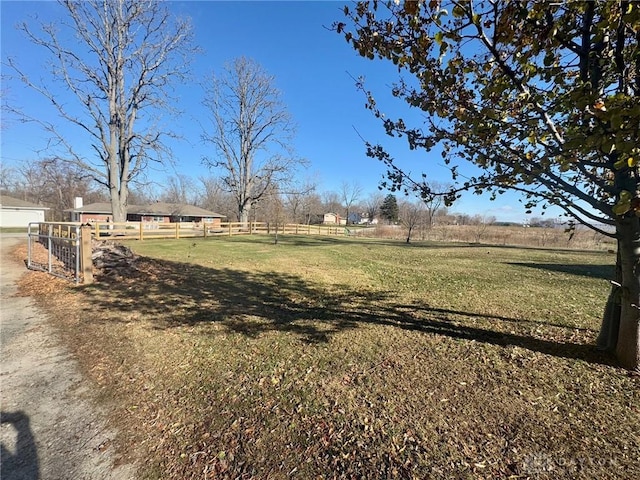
[0,159,492,228]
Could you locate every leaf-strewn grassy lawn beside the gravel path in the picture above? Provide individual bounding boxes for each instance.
[20,236,640,479]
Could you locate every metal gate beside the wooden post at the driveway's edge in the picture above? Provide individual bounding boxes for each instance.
[27,222,81,283]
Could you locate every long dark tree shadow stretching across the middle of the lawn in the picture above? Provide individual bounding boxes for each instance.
[80,257,613,365]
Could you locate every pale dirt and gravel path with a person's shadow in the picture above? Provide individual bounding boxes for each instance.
[0,234,136,480]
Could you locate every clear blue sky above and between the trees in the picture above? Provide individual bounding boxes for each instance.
[1,0,548,221]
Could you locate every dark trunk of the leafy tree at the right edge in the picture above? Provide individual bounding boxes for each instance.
[598,216,640,371]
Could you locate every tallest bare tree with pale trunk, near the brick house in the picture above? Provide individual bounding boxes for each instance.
[8,0,196,221]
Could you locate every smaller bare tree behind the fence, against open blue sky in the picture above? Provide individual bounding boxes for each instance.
[202,57,304,223]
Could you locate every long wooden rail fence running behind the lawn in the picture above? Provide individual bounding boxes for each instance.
[92,222,348,240]
